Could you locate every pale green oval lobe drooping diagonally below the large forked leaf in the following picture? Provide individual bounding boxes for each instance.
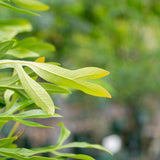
[16,64,55,115]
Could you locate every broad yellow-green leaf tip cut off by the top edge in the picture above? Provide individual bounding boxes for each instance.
[12,0,49,11]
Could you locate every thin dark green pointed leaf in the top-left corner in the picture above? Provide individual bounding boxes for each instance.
[0,1,38,16]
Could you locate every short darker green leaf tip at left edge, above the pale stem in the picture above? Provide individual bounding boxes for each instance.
[0,40,15,57]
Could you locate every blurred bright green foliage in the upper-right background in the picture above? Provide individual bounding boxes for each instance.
[28,0,160,107]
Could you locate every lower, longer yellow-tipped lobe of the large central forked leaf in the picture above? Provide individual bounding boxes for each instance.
[25,63,111,98]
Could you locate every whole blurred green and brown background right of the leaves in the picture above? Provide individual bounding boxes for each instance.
[0,0,160,160]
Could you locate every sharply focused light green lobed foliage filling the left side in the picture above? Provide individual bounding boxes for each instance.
[0,0,111,160]
